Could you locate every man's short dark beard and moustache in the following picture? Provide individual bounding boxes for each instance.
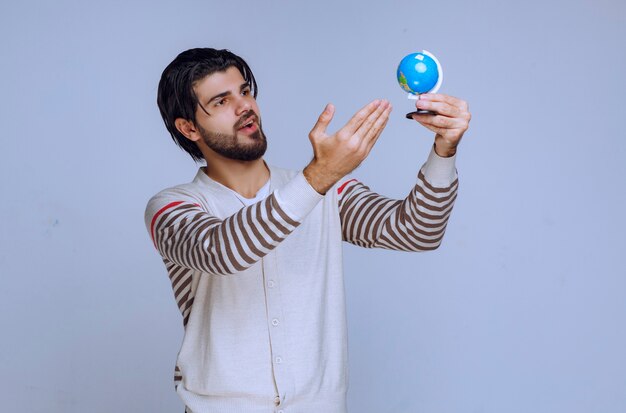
[196,110,267,161]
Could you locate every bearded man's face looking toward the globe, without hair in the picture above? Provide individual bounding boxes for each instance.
[194,67,267,161]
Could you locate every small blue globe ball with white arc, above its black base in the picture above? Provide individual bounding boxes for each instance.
[397,52,440,95]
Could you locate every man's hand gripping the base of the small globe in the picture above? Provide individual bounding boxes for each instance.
[413,93,472,158]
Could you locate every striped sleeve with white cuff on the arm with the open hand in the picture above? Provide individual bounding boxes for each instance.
[146,173,322,275]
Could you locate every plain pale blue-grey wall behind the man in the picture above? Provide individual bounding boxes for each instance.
[0,0,626,413]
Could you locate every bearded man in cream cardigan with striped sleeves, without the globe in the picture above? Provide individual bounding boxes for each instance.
[146,49,470,413]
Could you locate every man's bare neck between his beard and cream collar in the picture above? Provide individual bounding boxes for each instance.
[204,156,270,198]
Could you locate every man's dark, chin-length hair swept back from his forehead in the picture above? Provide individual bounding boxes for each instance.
[157,48,257,161]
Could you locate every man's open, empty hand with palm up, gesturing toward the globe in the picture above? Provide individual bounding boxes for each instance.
[303,100,391,194]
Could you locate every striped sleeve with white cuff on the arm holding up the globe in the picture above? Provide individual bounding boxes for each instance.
[338,151,458,251]
